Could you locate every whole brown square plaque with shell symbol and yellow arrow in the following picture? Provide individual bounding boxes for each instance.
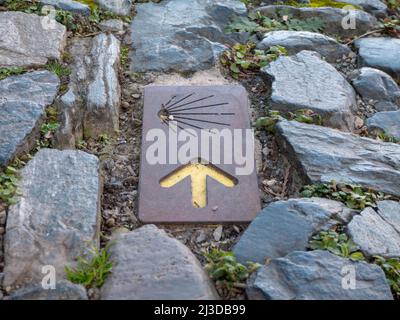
[139,86,260,222]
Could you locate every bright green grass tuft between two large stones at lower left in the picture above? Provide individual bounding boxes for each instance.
[65,242,113,288]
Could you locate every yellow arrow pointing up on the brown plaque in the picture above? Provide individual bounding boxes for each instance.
[160,163,237,208]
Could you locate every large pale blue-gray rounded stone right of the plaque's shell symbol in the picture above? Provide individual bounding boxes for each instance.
[261,51,356,130]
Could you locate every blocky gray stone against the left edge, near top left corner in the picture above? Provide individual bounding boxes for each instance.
[0,12,66,67]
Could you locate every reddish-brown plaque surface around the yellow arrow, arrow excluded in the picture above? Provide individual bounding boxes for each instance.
[138,85,260,223]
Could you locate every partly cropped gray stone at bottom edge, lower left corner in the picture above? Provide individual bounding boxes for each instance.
[7,281,88,300]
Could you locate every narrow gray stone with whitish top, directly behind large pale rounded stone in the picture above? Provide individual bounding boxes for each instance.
[257,30,351,62]
